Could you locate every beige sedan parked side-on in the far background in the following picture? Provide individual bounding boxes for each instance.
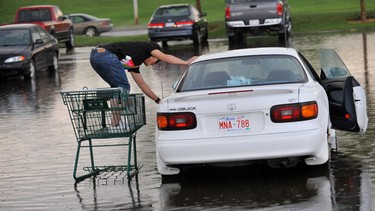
[69,13,113,37]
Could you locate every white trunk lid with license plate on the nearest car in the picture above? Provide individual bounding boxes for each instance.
[168,84,301,135]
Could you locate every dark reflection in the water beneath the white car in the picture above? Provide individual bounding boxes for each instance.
[160,154,372,210]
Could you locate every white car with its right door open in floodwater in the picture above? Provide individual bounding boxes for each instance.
[155,48,368,175]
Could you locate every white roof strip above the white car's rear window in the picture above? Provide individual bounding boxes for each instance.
[194,47,298,62]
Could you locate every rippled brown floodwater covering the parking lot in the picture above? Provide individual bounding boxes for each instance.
[0,33,375,210]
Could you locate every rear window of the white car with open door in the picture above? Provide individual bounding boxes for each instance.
[177,55,307,92]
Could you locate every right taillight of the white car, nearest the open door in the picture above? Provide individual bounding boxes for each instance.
[271,101,318,122]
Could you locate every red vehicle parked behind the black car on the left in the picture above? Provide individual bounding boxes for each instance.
[14,5,74,48]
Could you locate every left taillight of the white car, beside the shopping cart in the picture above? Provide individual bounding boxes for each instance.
[157,112,197,130]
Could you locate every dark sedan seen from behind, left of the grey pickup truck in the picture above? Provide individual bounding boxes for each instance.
[147,4,208,46]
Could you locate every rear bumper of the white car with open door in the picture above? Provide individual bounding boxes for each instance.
[157,129,327,165]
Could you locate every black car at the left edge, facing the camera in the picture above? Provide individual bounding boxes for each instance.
[0,24,60,78]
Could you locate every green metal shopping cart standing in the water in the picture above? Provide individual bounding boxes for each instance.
[61,88,146,181]
